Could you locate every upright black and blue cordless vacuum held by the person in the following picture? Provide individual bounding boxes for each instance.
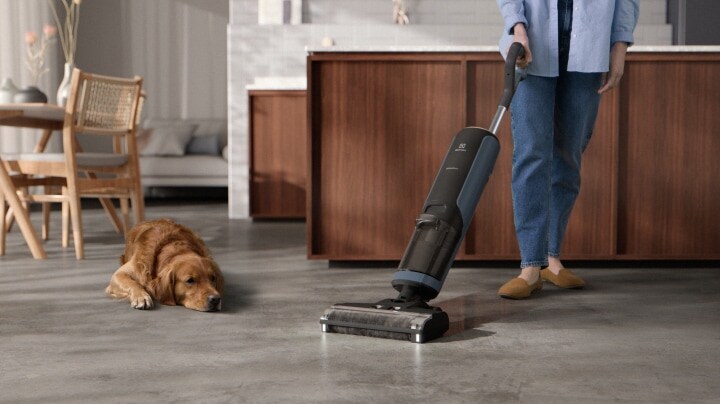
[320,43,524,343]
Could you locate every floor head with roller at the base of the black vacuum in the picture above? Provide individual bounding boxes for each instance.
[320,299,450,344]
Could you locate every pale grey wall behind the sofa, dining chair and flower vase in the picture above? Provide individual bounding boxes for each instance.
[0,0,230,152]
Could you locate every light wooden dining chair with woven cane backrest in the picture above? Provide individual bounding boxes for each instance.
[0,69,145,259]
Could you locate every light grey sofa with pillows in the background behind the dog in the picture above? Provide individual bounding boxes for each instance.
[137,118,228,189]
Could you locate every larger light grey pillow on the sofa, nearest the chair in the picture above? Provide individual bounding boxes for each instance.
[137,123,195,156]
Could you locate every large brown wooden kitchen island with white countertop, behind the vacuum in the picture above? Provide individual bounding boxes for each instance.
[306,47,720,261]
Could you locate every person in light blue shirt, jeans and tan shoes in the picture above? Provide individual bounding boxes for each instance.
[497,0,639,299]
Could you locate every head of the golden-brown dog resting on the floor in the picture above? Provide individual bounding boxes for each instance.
[155,253,224,311]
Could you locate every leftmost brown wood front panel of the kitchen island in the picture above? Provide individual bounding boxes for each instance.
[308,60,464,260]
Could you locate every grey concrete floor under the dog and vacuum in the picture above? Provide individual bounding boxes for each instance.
[0,204,720,403]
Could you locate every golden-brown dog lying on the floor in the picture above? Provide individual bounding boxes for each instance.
[105,219,224,312]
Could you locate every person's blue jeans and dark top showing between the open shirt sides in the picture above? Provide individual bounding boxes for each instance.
[510,0,602,268]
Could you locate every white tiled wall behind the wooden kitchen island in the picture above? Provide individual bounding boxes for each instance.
[228,0,672,218]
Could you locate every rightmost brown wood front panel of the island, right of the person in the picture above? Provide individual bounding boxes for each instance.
[618,55,720,259]
